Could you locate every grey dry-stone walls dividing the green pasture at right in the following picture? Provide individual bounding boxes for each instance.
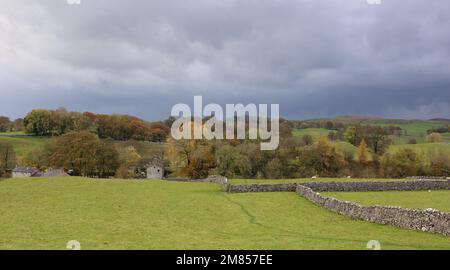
[223,180,450,236]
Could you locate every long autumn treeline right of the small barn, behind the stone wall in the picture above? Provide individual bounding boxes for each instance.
[167,135,450,179]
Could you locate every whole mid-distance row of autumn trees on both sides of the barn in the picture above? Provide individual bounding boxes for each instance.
[7,131,450,179]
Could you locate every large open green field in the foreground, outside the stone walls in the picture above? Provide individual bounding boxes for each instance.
[0,177,450,249]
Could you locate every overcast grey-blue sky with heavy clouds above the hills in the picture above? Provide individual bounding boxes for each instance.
[0,0,450,120]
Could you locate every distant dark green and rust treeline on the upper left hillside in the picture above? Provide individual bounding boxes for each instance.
[23,108,170,142]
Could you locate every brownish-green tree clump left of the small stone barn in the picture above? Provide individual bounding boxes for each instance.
[19,131,163,178]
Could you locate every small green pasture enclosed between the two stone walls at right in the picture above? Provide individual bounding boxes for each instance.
[323,190,450,212]
